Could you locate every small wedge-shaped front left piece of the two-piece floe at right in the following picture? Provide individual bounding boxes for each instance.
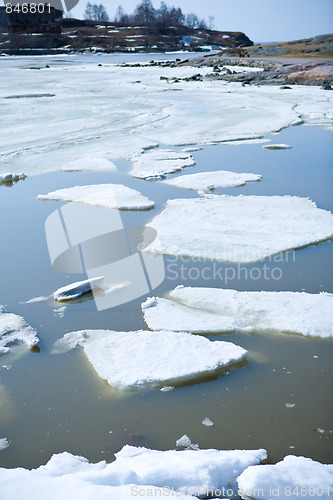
[141,297,244,333]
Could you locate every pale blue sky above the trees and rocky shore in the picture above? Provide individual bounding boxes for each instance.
[71,0,333,43]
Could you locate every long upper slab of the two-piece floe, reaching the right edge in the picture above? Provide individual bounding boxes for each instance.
[167,286,333,338]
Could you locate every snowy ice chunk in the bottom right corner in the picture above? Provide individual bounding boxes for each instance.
[237,455,333,500]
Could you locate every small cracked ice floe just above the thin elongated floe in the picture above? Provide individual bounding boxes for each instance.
[130,149,195,179]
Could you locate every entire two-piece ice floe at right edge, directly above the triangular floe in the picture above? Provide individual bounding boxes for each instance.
[157,286,333,338]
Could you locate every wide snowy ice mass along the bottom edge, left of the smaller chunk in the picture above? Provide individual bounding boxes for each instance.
[0,445,267,500]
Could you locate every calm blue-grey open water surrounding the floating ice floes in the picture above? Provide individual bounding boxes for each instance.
[0,126,333,468]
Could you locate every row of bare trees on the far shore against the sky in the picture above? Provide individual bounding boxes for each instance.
[84,0,214,32]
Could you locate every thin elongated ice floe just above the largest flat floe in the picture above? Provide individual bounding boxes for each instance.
[164,170,262,191]
